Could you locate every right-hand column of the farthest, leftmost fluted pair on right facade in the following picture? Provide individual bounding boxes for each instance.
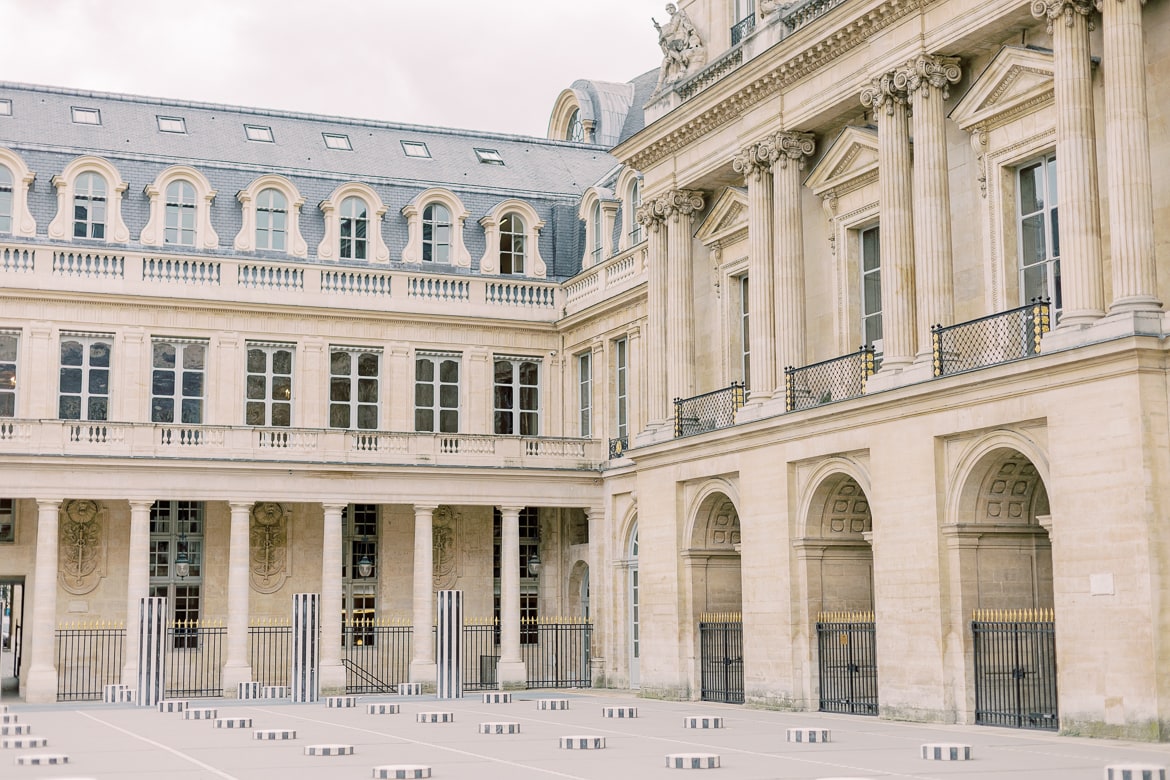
[659,189,703,400]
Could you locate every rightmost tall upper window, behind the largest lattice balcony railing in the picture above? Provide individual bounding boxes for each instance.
[1017,154,1064,316]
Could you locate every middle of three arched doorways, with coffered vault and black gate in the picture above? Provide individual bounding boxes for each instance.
[796,463,878,715]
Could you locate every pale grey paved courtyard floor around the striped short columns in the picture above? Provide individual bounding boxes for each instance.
[0,691,1170,780]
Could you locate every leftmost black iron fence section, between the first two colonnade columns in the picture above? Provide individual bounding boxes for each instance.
[55,623,126,702]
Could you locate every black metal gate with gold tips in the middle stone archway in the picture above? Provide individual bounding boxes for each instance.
[817,612,878,715]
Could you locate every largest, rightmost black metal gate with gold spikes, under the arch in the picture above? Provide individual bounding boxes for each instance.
[971,609,1060,731]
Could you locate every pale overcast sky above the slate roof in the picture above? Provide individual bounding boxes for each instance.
[0,0,668,136]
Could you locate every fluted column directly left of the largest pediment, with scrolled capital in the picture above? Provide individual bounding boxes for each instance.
[902,54,962,364]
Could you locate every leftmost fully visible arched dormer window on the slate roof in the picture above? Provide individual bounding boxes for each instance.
[49,156,130,243]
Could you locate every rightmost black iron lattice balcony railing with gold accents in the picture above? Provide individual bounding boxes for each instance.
[930,298,1052,377]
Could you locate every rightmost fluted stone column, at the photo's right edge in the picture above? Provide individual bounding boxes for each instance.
[1099,0,1162,313]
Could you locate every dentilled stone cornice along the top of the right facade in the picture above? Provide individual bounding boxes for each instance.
[614,0,938,171]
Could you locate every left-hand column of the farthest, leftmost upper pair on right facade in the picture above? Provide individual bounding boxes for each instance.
[631,200,670,434]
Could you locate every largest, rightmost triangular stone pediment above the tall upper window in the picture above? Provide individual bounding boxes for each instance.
[951,46,1053,130]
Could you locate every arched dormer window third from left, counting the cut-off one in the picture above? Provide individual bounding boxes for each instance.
[138,165,219,249]
